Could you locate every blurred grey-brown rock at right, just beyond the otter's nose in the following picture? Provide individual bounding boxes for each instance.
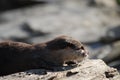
[89,41,120,70]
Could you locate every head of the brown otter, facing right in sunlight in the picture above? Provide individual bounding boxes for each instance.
[47,36,88,63]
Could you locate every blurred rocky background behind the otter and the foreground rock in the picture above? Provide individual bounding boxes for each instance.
[0,0,120,71]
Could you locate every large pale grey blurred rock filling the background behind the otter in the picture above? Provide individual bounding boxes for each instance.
[0,0,120,43]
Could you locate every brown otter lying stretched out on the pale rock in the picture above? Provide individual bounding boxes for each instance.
[0,36,88,75]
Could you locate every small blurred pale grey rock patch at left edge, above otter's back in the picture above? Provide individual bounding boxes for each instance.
[0,23,28,40]
